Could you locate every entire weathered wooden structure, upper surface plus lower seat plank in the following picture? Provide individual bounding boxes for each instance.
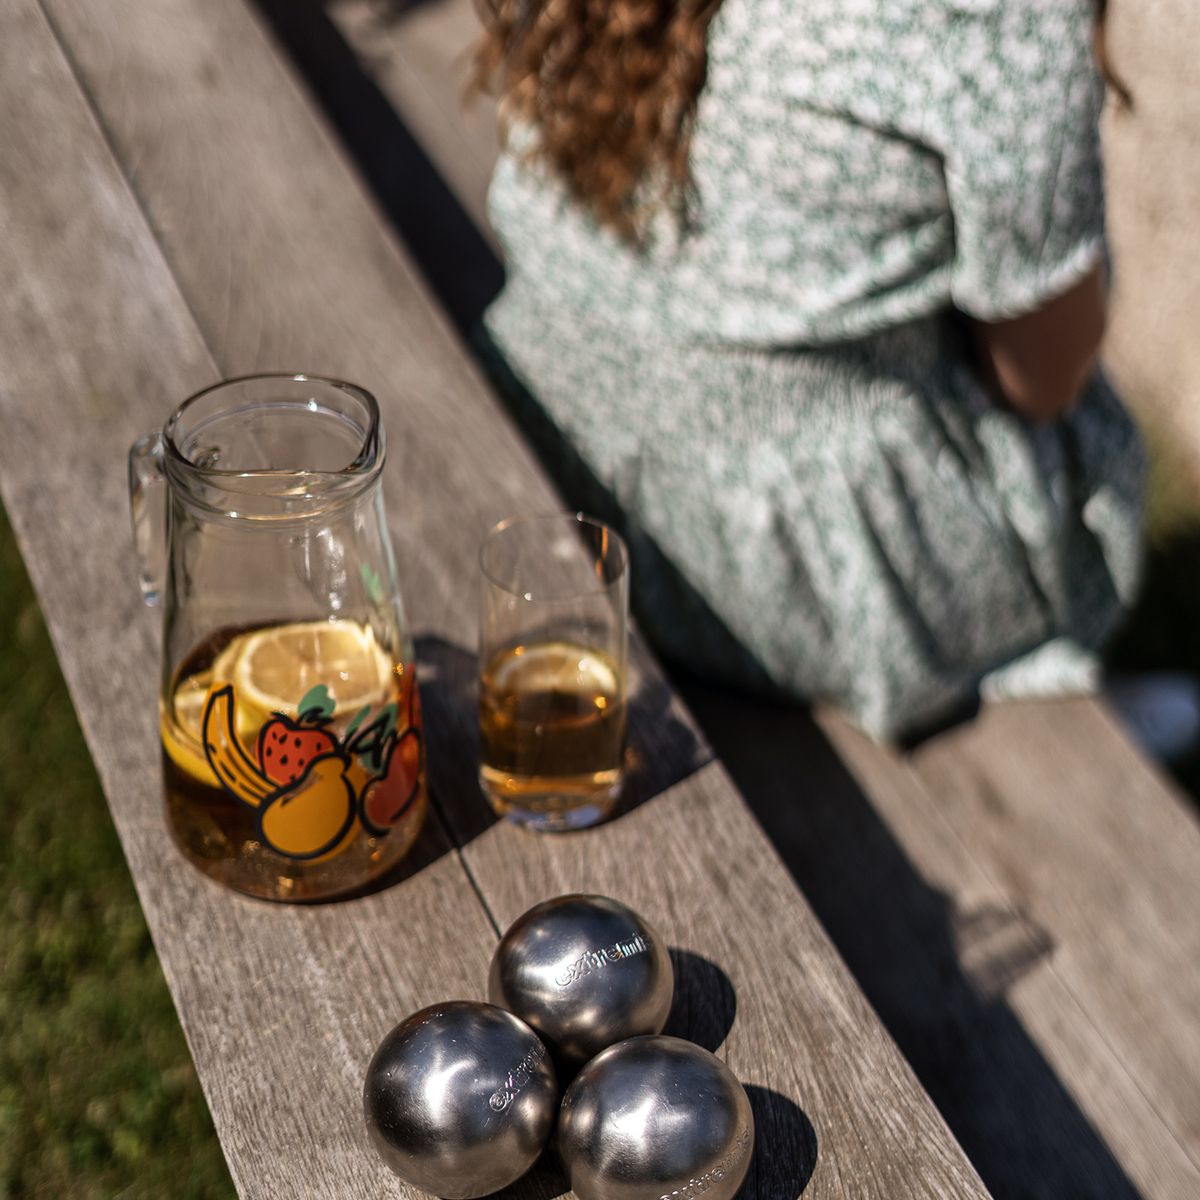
[7,0,1200,1200]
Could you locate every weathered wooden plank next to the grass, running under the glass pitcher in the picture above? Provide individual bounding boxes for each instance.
[0,0,511,1198]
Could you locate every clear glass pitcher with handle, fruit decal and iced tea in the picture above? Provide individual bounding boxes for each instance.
[130,376,426,900]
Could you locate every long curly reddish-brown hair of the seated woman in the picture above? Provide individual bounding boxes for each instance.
[473,0,1132,242]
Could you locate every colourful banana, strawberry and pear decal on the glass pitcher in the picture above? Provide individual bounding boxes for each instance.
[202,673,422,860]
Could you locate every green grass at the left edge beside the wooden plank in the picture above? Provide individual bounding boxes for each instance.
[0,510,234,1200]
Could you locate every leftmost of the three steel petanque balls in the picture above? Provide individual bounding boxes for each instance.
[362,1000,558,1200]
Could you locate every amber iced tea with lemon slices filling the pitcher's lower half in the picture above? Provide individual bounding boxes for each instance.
[160,622,425,899]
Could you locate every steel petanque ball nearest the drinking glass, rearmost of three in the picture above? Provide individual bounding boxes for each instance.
[487,895,674,1066]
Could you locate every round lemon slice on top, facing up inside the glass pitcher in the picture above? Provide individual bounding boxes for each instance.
[236,620,394,720]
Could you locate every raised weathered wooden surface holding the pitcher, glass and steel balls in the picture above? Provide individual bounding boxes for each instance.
[0,0,986,1200]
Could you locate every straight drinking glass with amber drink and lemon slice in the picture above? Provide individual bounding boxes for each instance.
[479,514,629,830]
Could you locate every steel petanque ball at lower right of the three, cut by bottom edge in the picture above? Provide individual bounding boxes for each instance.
[558,1037,754,1200]
